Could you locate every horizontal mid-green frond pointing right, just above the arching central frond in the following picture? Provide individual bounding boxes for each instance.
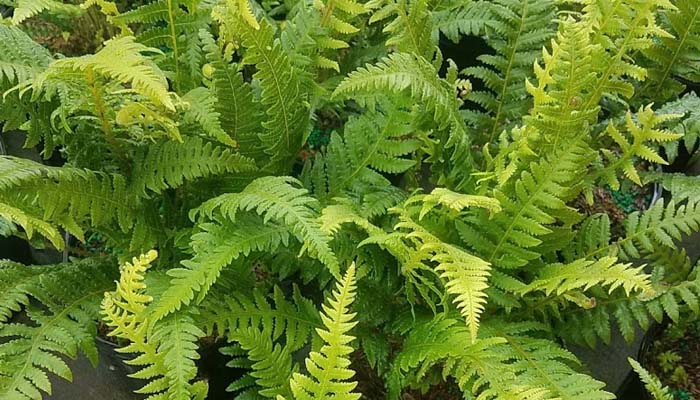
[130,137,256,194]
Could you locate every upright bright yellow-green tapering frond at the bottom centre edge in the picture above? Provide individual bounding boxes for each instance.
[290,264,360,400]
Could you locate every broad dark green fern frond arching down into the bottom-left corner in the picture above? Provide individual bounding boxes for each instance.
[0,259,114,400]
